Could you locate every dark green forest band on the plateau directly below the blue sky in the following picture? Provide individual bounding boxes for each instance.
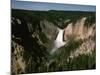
[12,9,96,28]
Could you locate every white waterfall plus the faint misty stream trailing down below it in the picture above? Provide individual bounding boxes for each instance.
[46,28,66,67]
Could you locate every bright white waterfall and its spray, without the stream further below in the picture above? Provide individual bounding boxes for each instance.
[50,28,66,55]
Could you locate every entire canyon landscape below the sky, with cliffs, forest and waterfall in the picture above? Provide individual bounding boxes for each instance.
[11,10,96,74]
